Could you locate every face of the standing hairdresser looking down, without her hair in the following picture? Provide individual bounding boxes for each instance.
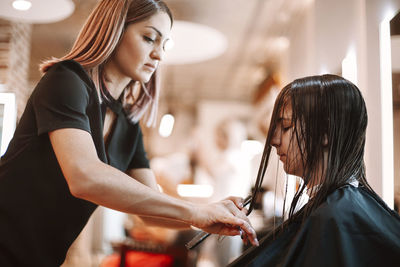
[111,12,171,83]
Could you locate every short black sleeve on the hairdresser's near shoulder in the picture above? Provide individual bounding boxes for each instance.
[32,65,90,135]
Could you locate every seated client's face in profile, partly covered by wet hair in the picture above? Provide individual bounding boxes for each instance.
[271,105,303,177]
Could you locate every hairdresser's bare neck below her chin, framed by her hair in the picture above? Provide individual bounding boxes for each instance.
[104,61,131,99]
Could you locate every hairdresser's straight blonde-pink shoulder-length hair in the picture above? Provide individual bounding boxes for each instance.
[40,0,173,126]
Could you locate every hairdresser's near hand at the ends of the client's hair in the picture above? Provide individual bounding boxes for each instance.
[192,199,258,246]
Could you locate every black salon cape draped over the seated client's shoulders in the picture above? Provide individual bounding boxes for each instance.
[229,185,400,267]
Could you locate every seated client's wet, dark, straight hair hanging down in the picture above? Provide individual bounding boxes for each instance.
[249,74,373,226]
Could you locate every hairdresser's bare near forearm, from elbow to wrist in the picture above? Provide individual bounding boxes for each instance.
[71,161,195,224]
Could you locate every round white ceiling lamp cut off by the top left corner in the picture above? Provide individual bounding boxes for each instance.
[0,0,75,24]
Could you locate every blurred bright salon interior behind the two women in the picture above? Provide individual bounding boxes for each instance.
[0,0,400,267]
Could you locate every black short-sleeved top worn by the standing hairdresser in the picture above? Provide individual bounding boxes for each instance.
[0,60,149,267]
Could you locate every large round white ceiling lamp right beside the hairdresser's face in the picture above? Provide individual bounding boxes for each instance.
[164,20,228,65]
